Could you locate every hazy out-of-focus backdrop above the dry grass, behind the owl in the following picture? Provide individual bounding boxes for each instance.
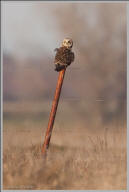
[2,2,127,141]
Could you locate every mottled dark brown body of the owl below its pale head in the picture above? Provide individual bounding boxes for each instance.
[54,47,74,71]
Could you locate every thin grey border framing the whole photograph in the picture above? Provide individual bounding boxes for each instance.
[0,0,129,192]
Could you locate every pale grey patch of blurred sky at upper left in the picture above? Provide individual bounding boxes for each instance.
[2,1,62,57]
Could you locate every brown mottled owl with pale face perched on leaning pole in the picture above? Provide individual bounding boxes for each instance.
[54,38,74,71]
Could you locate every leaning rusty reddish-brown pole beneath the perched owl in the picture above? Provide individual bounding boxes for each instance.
[42,69,66,154]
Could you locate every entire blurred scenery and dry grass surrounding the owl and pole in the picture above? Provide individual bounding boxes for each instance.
[2,1,127,190]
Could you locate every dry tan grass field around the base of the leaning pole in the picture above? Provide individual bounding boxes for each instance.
[3,103,127,190]
